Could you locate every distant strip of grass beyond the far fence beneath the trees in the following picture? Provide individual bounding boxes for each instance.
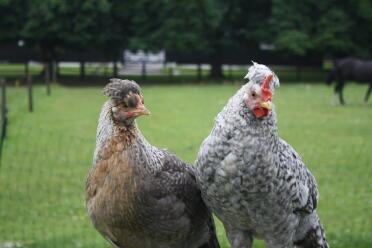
[0,61,326,85]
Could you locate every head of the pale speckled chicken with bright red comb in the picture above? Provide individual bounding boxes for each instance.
[243,62,279,118]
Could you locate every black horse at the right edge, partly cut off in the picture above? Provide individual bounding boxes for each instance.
[326,58,372,105]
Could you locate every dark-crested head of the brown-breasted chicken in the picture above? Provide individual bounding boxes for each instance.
[104,78,150,124]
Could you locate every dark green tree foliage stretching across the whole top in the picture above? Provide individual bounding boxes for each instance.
[0,0,372,71]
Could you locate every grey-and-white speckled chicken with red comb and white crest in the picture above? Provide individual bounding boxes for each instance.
[196,63,328,248]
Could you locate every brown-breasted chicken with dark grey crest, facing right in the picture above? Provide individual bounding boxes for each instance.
[86,79,219,248]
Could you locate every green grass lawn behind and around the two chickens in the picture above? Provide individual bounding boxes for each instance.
[0,80,372,248]
